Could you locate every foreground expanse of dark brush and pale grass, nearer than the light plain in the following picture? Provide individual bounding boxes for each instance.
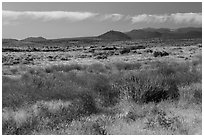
[2,56,202,135]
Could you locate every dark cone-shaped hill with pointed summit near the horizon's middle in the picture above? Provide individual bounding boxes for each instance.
[98,30,131,40]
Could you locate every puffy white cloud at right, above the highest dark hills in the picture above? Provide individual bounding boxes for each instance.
[130,13,202,25]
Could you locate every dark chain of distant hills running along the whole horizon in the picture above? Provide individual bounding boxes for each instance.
[2,27,202,47]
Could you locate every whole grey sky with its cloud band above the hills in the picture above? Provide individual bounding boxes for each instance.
[2,2,202,39]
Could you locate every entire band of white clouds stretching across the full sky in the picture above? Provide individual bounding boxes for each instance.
[2,10,202,25]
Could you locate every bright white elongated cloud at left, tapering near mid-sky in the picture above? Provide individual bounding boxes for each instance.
[2,11,98,21]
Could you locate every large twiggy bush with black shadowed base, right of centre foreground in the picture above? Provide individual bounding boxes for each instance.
[122,71,179,103]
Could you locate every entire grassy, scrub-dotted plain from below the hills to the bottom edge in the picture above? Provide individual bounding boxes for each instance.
[2,38,202,135]
